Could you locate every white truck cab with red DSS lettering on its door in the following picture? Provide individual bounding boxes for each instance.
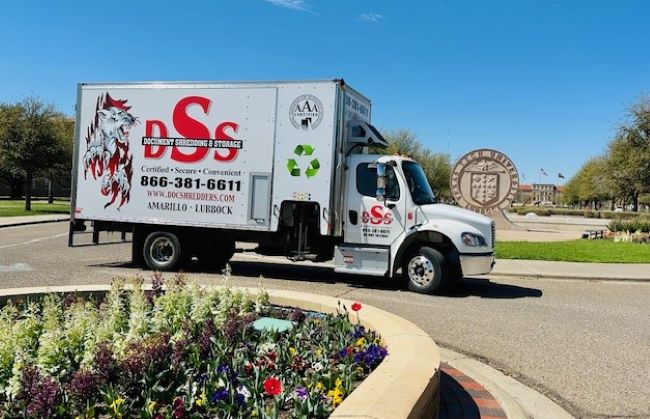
[335,154,495,293]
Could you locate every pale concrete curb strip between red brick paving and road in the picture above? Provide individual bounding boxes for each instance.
[440,348,573,419]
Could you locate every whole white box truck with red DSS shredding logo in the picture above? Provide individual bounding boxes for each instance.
[69,80,495,293]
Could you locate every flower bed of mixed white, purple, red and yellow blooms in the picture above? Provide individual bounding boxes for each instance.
[0,270,387,418]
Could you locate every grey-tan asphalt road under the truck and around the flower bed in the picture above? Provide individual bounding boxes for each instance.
[0,223,650,418]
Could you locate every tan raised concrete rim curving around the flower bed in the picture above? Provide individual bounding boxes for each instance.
[0,285,440,419]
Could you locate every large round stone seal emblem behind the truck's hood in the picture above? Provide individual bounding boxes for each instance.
[451,149,519,214]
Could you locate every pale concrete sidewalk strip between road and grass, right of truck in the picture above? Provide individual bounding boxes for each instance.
[490,259,650,281]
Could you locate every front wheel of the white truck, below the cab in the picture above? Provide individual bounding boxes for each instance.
[402,246,447,294]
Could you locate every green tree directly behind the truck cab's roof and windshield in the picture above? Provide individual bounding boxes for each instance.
[374,128,451,199]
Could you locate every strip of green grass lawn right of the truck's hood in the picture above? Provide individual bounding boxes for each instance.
[496,240,650,263]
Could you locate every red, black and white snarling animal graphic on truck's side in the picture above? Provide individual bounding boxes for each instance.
[83,93,138,209]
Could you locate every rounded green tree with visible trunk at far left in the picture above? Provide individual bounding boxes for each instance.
[0,97,70,211]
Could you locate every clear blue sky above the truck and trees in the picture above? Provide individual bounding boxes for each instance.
[0,0,650,183]
